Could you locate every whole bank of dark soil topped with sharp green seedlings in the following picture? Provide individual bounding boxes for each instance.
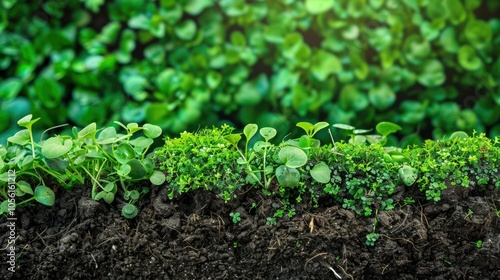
[0,115,500,279]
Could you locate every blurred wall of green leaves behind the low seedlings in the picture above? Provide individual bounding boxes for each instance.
[0,0,500,142]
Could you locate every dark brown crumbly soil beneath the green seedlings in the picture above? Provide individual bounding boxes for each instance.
[0,180,500,279]
